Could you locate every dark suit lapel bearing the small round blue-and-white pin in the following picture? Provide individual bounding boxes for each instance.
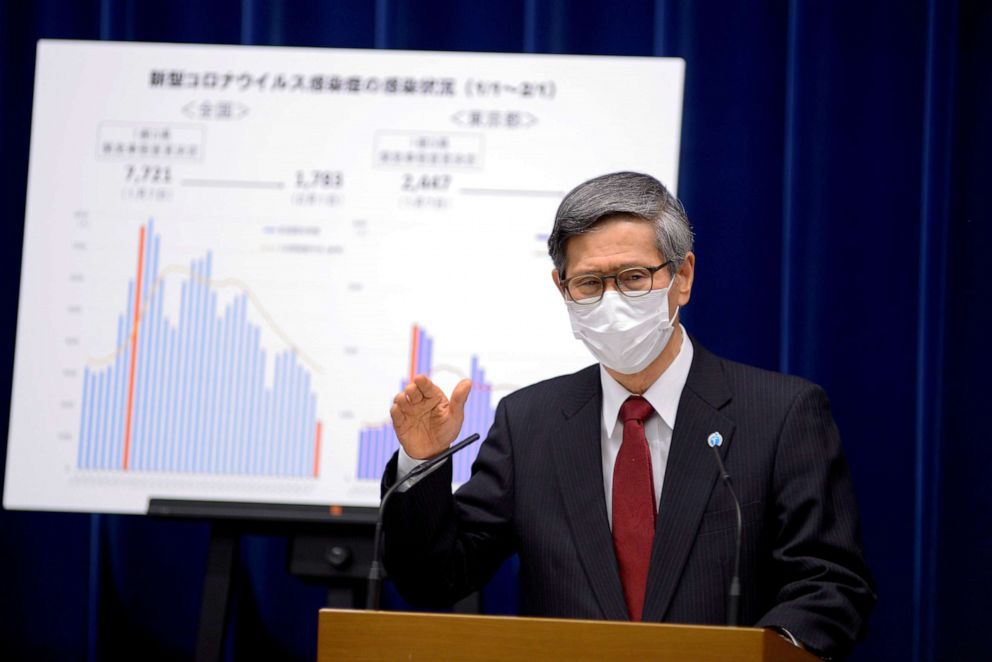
[644,340,734,621]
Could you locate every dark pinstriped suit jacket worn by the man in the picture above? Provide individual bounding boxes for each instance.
[383,340,875,655]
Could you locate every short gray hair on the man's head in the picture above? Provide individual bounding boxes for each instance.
[548,172,692,275]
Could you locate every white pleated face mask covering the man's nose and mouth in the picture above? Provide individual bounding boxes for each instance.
[565,278,679,375]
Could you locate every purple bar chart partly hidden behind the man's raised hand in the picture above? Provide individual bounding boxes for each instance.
[357,325,496,483]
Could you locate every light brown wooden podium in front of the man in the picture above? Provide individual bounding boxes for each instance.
[317,609,817,662]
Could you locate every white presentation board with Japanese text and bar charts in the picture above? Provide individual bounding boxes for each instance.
[4,41,684,513]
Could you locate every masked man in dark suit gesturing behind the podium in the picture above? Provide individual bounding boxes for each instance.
[383,172,875,656]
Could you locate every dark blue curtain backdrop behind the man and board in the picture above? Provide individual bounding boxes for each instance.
[0,0,992,660]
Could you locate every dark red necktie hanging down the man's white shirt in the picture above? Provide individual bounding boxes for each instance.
[613,395,655,621]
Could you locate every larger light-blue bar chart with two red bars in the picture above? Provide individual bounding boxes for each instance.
[76,221,322,478]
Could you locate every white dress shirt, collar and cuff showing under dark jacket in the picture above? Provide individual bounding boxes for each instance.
[396,324,692,528]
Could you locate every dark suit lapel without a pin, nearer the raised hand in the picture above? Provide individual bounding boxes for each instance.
[552,366,627,620]
